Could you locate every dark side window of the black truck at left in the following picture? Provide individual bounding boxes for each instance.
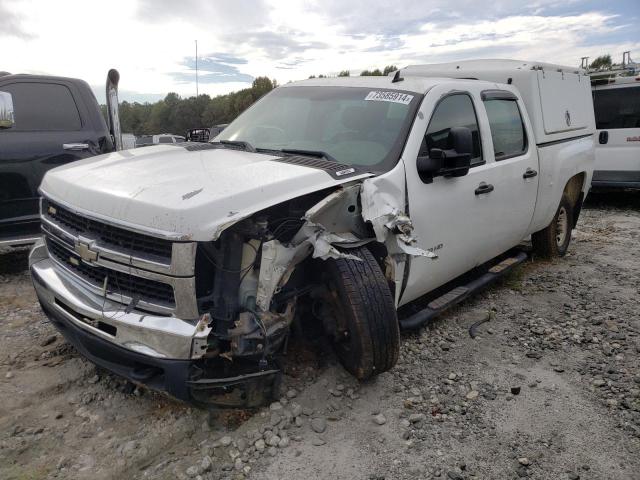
[2,82,82,131]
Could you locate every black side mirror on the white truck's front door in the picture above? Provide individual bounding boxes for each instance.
[416,127,473,183]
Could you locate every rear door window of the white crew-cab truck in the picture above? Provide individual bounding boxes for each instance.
[484,97,527,161]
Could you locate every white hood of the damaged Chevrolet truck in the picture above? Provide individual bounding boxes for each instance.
[40,145,371,241]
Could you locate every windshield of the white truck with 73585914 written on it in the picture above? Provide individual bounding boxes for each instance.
[216,86,422,171]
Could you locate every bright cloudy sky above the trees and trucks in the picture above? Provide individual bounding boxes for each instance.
[0,0,640,101]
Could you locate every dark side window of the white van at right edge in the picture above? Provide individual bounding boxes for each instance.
[593,85,640,130]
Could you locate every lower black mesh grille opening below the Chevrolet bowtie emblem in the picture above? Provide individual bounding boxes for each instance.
[46,236,175,308]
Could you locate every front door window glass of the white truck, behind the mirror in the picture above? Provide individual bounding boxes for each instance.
[418,93,484,167]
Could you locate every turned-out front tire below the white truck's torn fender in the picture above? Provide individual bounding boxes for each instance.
[325,248,400,380]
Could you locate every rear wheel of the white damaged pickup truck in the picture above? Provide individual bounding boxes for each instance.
[531,194,574,258]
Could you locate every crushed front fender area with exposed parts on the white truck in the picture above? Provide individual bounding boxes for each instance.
[190,179,435,404]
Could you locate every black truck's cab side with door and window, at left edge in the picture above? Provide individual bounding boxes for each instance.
[0,79,100,242]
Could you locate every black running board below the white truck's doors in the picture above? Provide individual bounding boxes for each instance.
[400,252,528,330]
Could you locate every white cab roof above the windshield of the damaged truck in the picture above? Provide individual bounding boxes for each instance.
[282,75,478,94]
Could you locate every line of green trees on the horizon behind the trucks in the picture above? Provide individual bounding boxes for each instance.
[111,65,396,135]
